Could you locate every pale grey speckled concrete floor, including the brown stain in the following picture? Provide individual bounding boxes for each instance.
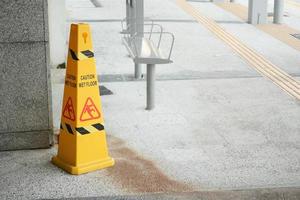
[0,0,300,199]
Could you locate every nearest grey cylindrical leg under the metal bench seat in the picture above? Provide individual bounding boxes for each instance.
[146,64,155,110]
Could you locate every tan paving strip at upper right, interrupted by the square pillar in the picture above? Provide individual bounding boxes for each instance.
[216,2,300,51]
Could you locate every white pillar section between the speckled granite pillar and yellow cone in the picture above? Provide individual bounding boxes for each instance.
[48,0,67,67]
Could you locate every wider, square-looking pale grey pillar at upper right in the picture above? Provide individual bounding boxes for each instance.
[248,0,268,24]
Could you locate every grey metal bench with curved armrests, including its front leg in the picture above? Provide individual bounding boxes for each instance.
[121,19,175,110]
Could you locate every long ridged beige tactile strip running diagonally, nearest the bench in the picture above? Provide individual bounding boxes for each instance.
[177,0,300,100]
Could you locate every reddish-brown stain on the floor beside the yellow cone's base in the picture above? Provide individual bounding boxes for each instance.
[107,135,193,193]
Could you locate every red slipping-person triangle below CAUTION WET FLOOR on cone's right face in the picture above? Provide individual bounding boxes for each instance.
[80,97,101,121]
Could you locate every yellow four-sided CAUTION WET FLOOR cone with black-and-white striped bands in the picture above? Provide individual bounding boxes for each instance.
[52,24,114,174]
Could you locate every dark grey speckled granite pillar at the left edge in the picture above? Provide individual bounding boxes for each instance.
[0,0,53,150]
